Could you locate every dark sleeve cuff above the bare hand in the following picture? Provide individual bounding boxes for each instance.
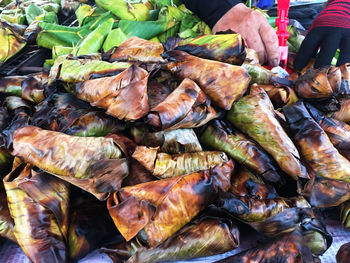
[183,0,241,28]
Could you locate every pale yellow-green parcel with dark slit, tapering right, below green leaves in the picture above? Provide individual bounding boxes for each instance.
[49,56,130,84]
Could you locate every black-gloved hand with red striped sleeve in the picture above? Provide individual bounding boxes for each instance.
[294,0,350,70]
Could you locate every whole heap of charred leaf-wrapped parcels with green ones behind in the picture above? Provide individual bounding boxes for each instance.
[0,1,350,263]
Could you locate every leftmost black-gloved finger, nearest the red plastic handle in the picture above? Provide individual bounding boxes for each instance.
[294,28,323,70]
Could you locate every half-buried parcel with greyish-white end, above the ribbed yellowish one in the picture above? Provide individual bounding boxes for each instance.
[131,127,202,154]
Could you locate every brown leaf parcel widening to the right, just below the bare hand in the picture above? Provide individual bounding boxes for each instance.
[163,50,250,110]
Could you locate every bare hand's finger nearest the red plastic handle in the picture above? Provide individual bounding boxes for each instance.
[259,17,280,67]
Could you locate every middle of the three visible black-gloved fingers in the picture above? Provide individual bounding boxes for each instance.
[314,34,340,68]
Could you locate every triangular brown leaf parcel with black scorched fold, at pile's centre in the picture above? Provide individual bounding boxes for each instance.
[147,79,217,130]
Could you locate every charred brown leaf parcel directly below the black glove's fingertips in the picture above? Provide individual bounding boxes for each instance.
[295,66,341,99]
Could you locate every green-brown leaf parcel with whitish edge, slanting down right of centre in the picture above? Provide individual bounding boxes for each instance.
[228,92,308,179]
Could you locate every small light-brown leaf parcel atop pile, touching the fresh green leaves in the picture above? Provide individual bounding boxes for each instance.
[109,37,165,63]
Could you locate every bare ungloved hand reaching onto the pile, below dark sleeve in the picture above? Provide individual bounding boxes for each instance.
[213,4,280,67]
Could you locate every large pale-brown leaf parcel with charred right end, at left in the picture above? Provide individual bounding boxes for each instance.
[13,126,129,200]
